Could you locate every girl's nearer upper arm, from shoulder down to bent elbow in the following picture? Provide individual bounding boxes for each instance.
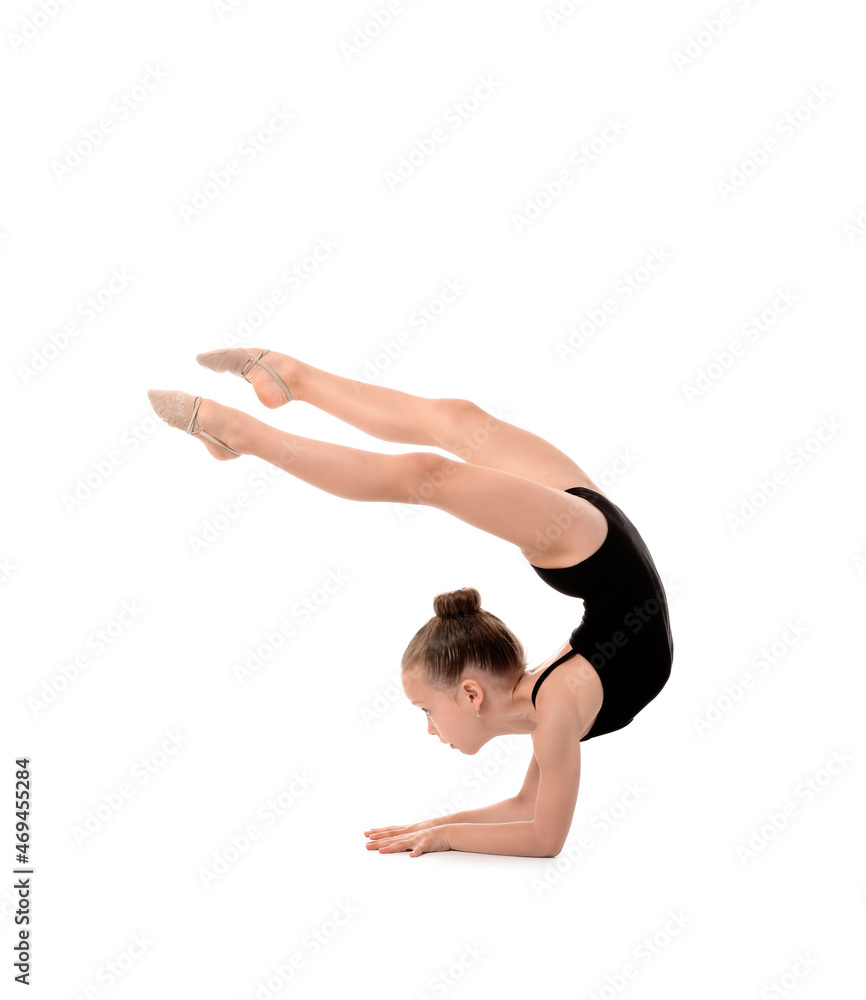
[533,692,580,855]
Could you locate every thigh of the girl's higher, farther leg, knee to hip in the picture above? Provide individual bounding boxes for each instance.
[435,399,604,496]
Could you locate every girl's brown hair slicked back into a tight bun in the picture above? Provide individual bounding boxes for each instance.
[401,587,526,689]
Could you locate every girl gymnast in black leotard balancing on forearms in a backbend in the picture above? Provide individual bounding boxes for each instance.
[148,348,673,857]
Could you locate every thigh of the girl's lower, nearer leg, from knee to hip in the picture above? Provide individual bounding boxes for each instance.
[404,451,607,567]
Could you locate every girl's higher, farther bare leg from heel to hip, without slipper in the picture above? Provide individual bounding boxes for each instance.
[248,348,601,492]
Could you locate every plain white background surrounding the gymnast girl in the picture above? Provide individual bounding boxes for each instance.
[0,0,866,1000]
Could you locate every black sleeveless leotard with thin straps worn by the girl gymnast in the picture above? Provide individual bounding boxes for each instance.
[530,486,674,742]
